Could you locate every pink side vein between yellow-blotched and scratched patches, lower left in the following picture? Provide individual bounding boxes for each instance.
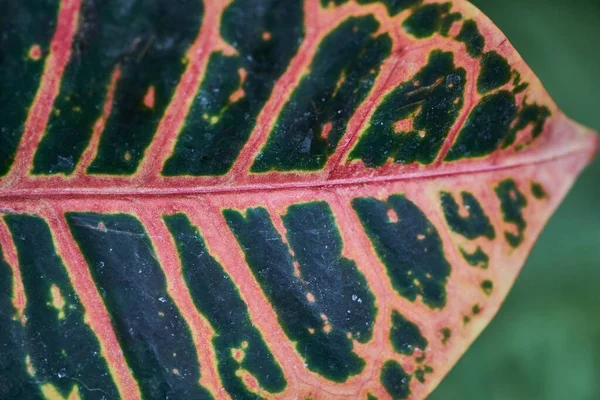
[44,204,141,400]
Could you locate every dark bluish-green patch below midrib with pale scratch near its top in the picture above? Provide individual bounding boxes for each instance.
[66,213,212,399]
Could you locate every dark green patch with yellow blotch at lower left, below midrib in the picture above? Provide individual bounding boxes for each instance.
[4,214,118,399]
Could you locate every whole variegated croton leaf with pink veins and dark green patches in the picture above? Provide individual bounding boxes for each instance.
[0,0,597,399]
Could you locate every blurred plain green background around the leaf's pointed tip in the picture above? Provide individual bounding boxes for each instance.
[429,0,600,400]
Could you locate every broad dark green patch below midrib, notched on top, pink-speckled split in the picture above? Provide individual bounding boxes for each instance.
[223,202,376,382]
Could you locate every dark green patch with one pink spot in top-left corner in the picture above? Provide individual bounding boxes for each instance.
[0,0,59,176]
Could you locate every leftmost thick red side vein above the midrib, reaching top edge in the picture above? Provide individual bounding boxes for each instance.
[6,0,82,182]
